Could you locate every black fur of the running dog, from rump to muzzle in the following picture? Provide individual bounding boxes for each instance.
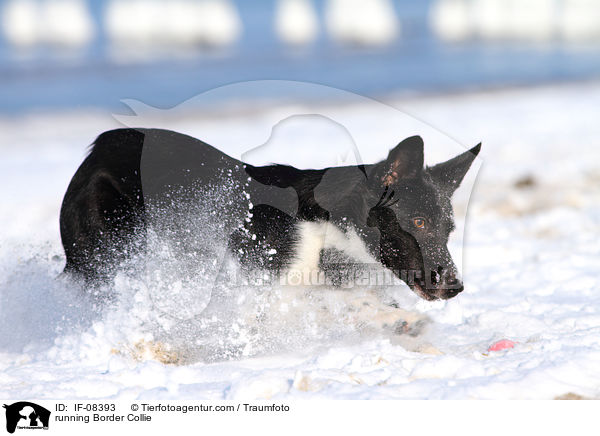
[60,128,480,299]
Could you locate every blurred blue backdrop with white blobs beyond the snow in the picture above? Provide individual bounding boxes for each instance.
[0,0,600,114]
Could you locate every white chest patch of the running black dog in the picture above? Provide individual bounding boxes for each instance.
[289,221,376,272]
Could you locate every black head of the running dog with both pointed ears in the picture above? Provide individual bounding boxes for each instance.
[367,136,481,300]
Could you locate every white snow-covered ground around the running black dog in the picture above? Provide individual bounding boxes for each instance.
[0,83,600,400]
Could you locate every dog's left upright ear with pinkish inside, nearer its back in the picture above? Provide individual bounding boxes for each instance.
[373,136,423,186]
